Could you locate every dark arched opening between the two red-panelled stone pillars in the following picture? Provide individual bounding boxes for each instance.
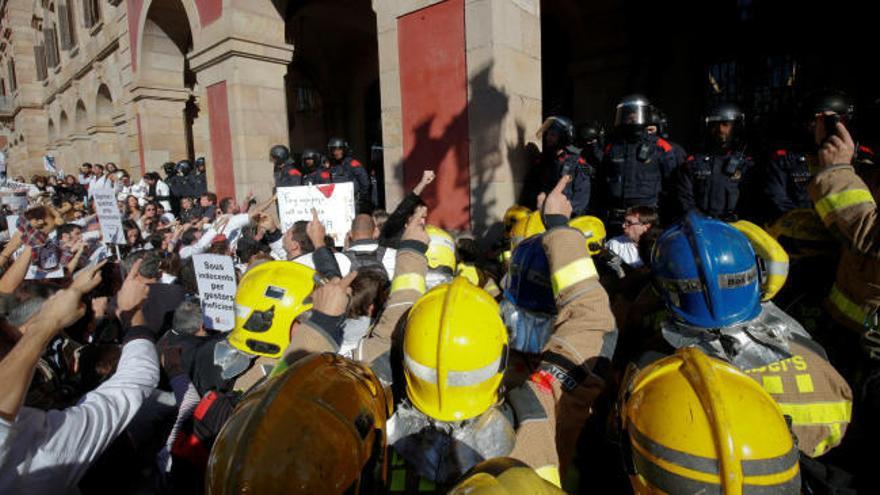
[284,0,382,192]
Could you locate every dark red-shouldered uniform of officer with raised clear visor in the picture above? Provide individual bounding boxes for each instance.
[599,134,676,221]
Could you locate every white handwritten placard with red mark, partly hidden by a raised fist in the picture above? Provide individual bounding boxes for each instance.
[276,182,355,246]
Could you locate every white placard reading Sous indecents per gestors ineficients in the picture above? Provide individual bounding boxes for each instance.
[193,254,236,331]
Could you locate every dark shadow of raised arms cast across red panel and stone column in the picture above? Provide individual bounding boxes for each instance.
[394,62,538,237]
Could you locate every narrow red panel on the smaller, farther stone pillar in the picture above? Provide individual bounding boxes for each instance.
[206,81,235,198]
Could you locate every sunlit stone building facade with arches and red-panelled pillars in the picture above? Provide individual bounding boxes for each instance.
[0,0,541,232]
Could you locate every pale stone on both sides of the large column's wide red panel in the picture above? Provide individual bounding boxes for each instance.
[373,0,542,233]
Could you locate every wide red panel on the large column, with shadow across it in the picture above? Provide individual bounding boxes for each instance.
[397,0,470,229]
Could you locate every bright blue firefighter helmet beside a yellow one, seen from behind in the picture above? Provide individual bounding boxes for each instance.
[651,212,761,328]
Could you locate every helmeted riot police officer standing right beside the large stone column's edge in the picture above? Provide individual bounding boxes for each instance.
[538,116,591,217]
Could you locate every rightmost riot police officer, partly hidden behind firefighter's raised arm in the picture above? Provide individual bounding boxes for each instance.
[764,91,853,221]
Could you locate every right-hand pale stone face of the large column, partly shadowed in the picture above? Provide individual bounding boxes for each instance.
[465,0,542,232]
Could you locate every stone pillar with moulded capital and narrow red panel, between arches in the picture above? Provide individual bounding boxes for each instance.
[190,38,293,202]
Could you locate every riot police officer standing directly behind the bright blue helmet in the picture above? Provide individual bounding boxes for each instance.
[675,103,754,221]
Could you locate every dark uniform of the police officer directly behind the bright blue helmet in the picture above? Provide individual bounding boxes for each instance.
[675,151,754,220]
